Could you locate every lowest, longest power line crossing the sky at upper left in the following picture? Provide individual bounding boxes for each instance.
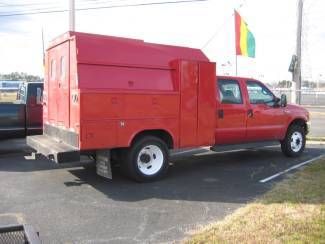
[0,0,209,17]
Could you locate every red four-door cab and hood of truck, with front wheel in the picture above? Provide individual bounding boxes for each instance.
[215,76,309,156]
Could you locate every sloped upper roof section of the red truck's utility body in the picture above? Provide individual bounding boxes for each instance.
[48,31,209,68]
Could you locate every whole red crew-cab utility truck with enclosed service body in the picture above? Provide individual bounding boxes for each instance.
[27,32,309,182]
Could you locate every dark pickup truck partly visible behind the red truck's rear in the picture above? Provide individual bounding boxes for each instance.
[0,82,43,139]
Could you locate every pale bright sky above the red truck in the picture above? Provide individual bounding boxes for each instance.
[0,0,325,83]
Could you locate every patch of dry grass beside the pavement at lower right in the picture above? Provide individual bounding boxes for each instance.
[185,159,325,244]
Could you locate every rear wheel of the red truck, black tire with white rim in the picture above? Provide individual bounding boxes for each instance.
[122,136,169,182]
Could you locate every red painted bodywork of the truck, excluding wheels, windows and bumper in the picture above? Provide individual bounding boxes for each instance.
[44,32,308,153]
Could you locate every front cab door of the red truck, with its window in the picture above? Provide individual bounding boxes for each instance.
[246,80,287,142]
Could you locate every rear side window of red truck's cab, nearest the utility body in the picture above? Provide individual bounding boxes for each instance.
[218,80,243,104]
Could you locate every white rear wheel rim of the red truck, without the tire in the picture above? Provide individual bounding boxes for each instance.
[137,145,164,176]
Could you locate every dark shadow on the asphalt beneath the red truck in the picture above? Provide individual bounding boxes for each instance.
[64,149,322,203]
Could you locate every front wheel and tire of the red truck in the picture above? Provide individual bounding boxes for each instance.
[281,125,306,157]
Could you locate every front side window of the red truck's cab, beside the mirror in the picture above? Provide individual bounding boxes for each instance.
[247,81,274,105]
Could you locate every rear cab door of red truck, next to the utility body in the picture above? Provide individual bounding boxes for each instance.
[215,78,247,145]
